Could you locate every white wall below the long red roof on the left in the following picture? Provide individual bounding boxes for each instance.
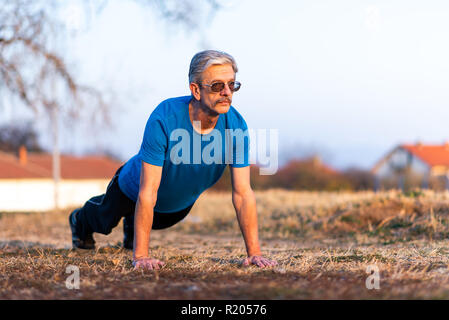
[0,179,110,212]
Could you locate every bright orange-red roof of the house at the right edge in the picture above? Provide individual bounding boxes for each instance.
[400,143,449,167]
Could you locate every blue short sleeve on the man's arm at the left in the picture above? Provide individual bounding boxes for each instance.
[139,118,168,167]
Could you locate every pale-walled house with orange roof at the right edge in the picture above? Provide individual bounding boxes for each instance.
[372,143,449,190]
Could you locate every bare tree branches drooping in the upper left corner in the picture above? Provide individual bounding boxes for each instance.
[0,0,108,126]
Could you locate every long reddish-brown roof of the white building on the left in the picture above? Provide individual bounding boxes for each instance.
[0,152,122,179]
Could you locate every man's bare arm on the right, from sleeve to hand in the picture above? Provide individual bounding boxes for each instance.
[230,166,277,267]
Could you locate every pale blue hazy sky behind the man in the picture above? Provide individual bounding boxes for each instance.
[0,0,449,169]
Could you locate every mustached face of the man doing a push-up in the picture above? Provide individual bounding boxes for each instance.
[194,64,235,113]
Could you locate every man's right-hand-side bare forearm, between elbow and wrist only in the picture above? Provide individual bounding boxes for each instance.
[232,191,261,256]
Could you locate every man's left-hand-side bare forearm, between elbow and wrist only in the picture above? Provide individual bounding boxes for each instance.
[134,198,154,259]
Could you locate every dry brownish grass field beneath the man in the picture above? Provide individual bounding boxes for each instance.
[0,190,449,299]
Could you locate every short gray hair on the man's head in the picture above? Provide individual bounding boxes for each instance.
[189,50,238,83]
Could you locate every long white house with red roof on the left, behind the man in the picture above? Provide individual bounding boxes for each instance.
[0,147,122,212]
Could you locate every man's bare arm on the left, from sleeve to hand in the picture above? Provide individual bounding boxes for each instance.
[133,161,164,269]
